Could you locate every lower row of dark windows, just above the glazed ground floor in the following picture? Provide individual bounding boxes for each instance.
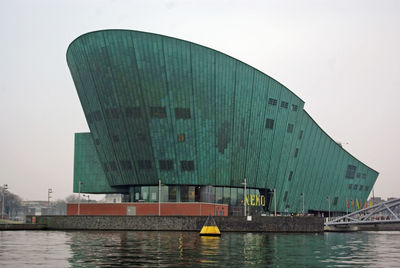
[103,160,194,172]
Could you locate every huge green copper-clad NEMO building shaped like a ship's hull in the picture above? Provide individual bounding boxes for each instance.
[67,30,378,215]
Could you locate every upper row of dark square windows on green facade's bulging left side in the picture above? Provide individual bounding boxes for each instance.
[86,106,191,123]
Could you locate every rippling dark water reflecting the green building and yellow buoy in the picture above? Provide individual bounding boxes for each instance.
[0,231,400,267]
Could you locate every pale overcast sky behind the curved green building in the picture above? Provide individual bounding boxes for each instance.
[0,0,400,200]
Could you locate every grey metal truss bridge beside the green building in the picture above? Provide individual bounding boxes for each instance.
[325,198,400,226]
